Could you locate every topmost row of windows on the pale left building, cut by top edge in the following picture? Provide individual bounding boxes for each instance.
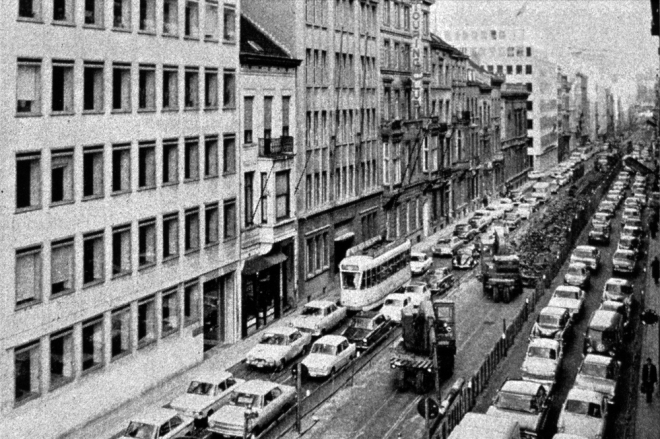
[18,0,236,43]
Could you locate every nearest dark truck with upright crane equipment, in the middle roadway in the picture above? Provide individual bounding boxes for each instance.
[390,300,456,394]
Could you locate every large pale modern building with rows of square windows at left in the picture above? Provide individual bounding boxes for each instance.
[0,0,242,438]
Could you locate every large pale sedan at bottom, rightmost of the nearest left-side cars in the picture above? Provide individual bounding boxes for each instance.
[208,380,296,438]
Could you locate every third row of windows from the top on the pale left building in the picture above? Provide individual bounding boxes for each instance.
[16,134,236,212]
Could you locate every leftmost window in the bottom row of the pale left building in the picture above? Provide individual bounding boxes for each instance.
[14,341,41,405]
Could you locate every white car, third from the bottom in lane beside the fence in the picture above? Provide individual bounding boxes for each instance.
[520,338,564,393]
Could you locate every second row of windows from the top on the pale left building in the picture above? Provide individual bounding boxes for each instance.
[16,58,236,116]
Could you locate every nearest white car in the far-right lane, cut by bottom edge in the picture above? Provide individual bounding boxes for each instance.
[557,387,608,439]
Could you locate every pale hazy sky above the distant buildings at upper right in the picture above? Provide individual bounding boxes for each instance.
[431,0,658,101]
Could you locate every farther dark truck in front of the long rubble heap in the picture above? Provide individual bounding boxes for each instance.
[480,232,523,303]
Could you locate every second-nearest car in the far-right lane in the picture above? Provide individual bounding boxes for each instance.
[575,354,621,404]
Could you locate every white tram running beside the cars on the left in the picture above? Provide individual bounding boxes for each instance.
[339,237,412,311]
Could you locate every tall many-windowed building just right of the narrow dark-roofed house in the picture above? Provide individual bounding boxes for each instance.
[242,0,383,300]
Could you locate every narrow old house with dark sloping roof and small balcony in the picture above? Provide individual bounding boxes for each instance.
[239,15,301,337]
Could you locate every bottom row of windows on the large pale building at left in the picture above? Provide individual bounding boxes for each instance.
[14,279,210,405]
